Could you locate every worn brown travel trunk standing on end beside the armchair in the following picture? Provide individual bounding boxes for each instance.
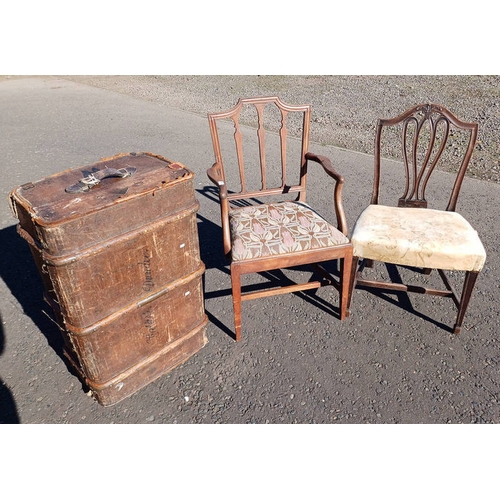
[10,153,207,406]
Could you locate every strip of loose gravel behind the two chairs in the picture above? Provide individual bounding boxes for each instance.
[65,75,500,183]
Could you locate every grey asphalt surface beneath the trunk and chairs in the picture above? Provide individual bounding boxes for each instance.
[0,77,500,432]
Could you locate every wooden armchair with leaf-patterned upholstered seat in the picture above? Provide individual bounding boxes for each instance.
[207,97,352,341]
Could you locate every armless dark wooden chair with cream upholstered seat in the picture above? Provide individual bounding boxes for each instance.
[348,104,486,334]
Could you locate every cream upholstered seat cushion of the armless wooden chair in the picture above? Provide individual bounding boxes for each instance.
[351,205,486,271]
